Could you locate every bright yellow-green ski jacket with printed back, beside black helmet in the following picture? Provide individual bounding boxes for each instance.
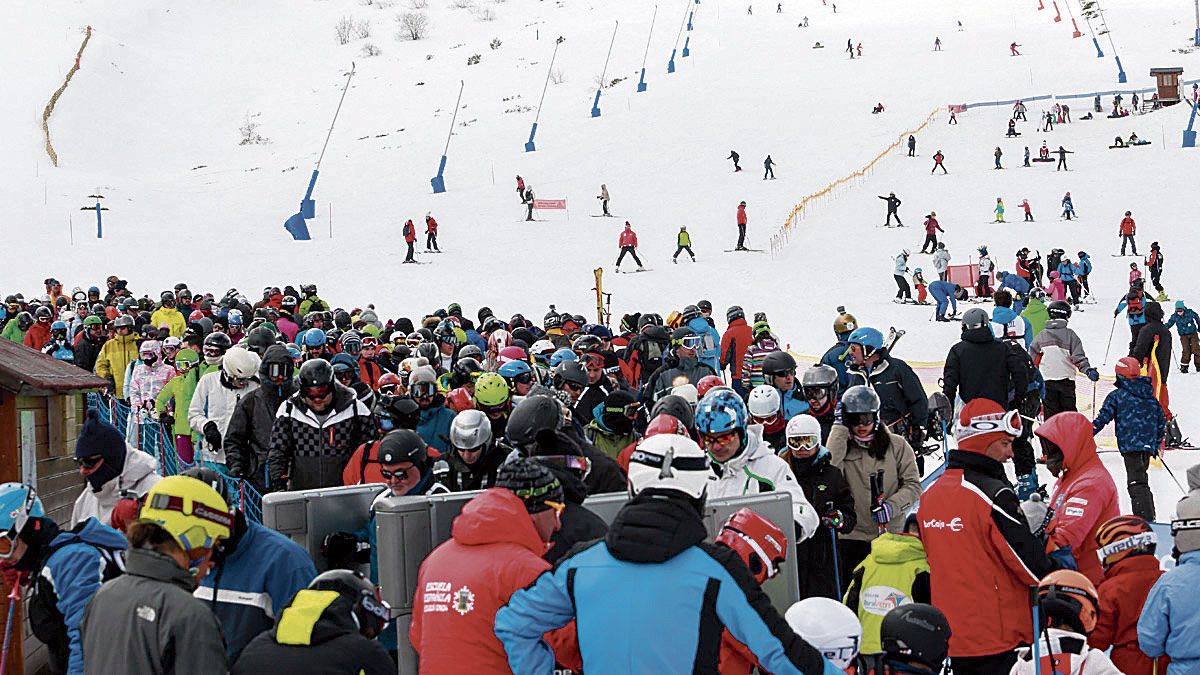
[846,532,929,653]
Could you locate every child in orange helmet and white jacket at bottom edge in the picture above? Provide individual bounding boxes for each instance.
[1009,569,1121,675]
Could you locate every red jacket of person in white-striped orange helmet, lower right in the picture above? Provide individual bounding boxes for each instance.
[1087,555,1168,675]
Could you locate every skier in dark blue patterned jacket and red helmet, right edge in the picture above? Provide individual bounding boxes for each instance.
[1092,357,1166,521]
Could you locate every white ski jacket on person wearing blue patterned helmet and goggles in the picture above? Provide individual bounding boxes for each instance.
[708,424,821,540]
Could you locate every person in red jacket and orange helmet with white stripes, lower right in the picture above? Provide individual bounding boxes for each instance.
[1087,515,1166,675]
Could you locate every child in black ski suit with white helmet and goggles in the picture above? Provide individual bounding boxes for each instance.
[780,414,858,599]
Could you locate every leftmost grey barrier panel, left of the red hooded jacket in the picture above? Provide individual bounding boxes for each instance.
[263,485,384,572]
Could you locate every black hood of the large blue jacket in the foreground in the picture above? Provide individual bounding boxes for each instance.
[605,490,708,563]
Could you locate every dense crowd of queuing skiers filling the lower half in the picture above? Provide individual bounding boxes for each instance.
[0,277,1200,674]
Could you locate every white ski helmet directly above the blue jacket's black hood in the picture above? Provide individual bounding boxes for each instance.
[629,434,713,498]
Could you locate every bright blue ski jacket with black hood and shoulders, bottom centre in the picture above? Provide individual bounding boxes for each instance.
[492,491,840,675]
